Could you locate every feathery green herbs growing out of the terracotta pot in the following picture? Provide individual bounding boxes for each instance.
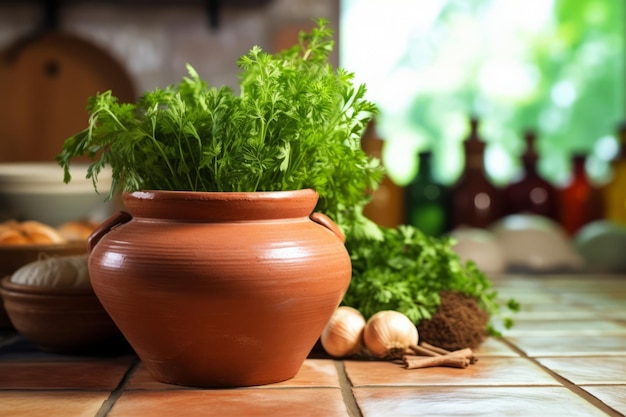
[57,19,382,231]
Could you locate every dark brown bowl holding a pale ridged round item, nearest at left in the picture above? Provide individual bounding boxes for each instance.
[0,276,120,353]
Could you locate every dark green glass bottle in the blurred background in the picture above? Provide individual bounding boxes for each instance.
[405,151,450,236]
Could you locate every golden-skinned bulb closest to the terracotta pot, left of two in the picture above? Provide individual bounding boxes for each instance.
[320,306,365,358]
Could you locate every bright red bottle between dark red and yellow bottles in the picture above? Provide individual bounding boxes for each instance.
[559,154,604,236]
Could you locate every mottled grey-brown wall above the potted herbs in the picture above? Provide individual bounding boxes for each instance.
[0,0,339,92]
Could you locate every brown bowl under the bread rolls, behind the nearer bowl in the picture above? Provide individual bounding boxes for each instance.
[0,241,87,329]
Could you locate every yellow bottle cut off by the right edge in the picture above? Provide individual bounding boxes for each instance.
[603,122,626,224]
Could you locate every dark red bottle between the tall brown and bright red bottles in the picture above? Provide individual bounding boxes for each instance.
[503,130,559,222]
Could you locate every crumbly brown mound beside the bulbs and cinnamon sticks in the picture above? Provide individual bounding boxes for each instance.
[417,291,489,350]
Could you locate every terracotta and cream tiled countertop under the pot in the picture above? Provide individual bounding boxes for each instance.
[0,275,626,417]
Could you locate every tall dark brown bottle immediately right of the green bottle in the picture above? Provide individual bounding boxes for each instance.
[452,118,502,228]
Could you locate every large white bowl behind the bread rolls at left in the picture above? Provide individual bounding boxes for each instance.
[0,162,113,227]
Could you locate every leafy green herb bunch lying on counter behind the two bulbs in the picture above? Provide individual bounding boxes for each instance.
[343,225,519,334]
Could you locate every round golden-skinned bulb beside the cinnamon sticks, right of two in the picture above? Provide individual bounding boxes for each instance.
[363,310,419,359]
